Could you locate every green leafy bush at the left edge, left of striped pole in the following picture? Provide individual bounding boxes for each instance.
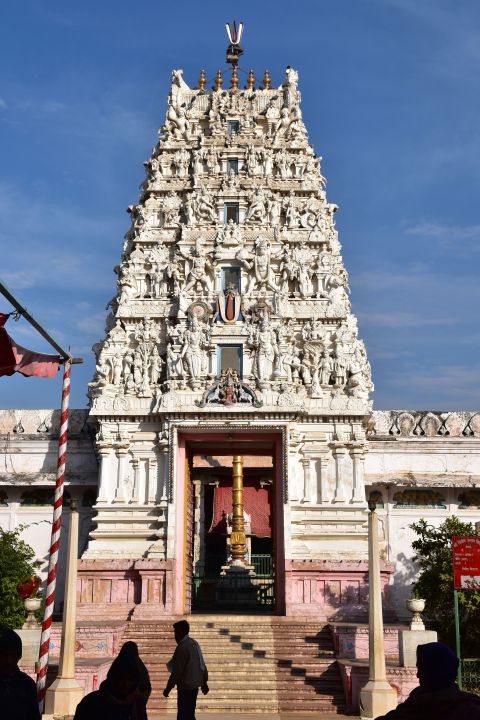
[0,527,38,629]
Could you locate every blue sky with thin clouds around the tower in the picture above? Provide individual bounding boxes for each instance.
[0,0,480,410]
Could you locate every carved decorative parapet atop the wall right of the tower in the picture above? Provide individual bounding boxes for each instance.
[367,410,480,439]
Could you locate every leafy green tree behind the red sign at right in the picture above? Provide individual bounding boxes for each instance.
[410,516,480,657]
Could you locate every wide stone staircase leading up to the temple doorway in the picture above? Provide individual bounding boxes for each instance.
[123,615,346,718]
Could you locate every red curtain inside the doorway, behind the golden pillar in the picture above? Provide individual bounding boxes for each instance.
[209,485,272,537]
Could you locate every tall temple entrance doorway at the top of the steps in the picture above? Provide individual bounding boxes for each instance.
[177,432,284,614]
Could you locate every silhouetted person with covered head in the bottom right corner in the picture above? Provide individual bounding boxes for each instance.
[377,643,480,720]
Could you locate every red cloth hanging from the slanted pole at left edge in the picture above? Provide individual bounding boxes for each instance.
[0,313,60,378]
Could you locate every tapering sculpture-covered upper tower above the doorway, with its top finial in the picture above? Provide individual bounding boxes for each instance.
[89,24,373,428]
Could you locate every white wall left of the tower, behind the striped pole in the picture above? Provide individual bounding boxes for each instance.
[0,410,98,609]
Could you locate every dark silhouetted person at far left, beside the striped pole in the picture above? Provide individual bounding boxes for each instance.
[0,630,40,720]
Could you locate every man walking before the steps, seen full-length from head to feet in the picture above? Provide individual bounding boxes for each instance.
[163,620,208,720]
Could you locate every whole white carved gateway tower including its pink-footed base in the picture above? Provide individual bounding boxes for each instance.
[79,39,373,619]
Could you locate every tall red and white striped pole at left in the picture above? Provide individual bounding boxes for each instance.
[37,360,71,712]
